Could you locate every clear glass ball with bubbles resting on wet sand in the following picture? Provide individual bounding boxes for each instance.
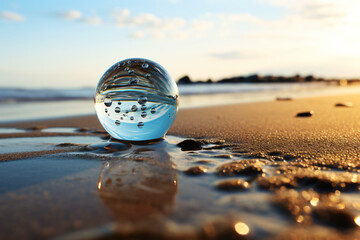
[95,58,179,141]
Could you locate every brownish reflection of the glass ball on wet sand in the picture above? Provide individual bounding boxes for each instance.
[98,142,177,222]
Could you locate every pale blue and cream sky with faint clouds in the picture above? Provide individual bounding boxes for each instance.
[0,0,360,88]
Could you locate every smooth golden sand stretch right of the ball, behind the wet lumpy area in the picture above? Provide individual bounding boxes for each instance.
[169,95,360,164]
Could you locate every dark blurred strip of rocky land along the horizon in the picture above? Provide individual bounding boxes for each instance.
[178,74,360,85]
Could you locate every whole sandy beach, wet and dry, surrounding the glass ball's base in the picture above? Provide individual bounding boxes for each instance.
[0,95,360,239]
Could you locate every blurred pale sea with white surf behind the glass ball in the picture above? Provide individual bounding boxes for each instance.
[0,82,360,123]
